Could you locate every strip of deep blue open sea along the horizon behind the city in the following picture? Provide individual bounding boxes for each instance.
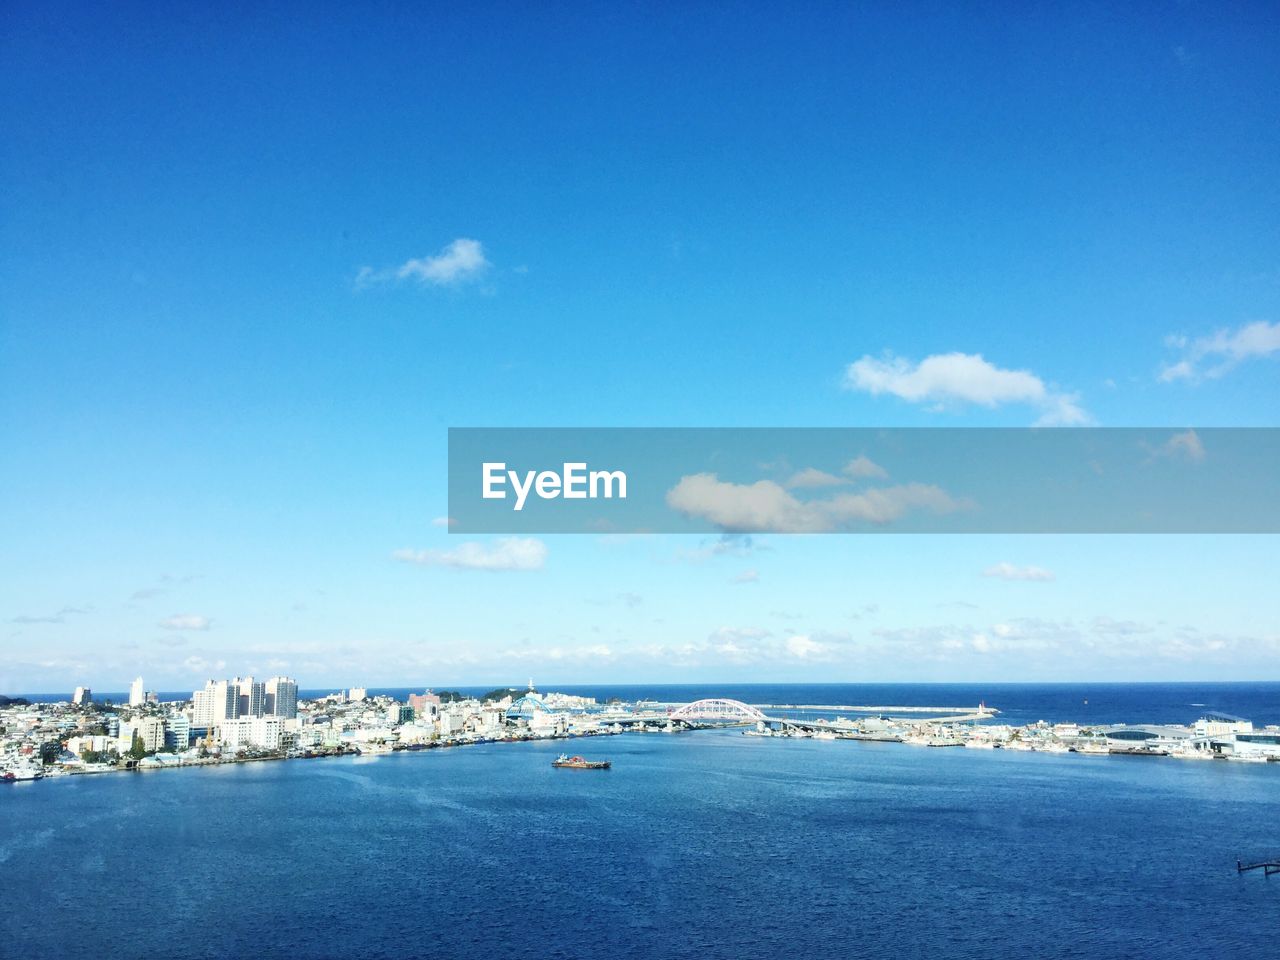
[27,682,1280,724]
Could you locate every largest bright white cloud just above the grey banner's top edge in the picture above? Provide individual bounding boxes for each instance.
[845,352,1089,426]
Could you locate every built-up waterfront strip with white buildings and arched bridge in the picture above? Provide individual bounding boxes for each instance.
[0,678,1280,783]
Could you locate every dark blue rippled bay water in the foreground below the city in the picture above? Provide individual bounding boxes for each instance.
[0,732,1280,960]
